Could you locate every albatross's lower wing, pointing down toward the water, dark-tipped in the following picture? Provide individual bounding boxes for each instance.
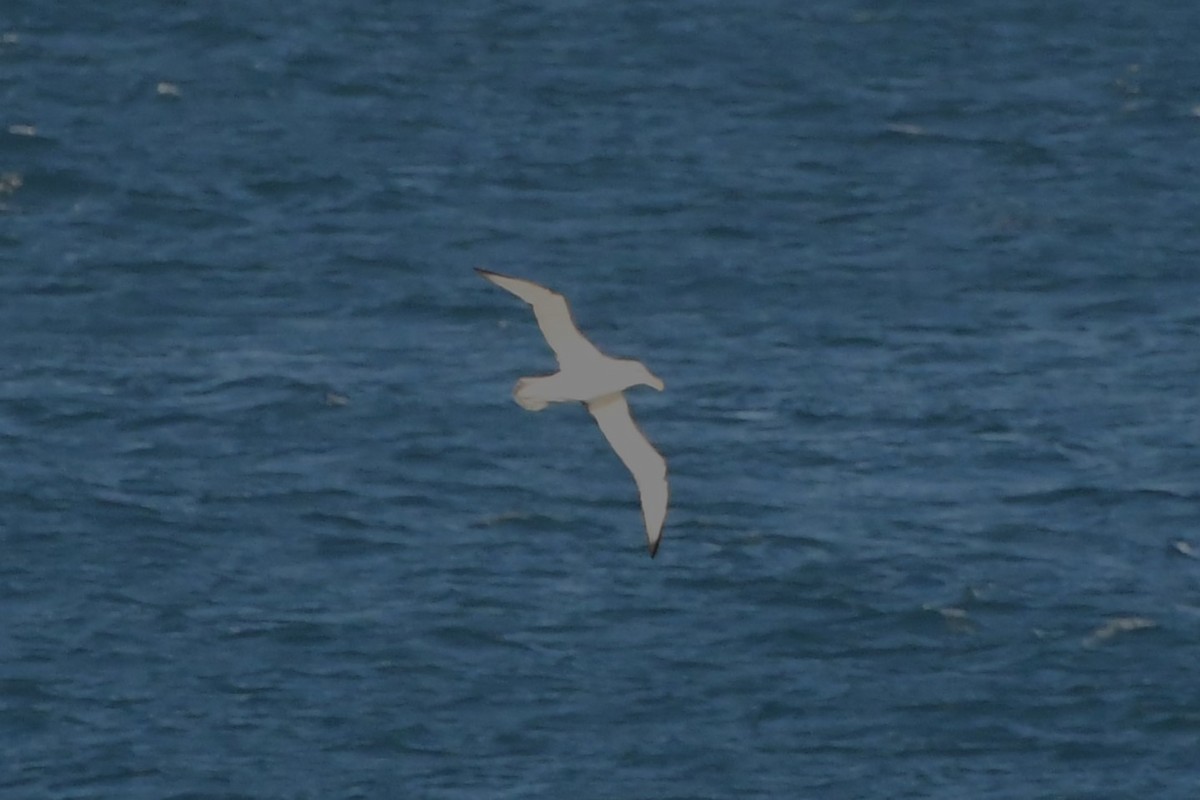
[587,392,670,558]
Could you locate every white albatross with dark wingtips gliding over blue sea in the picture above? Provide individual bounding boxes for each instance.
[475,267,668,558]
